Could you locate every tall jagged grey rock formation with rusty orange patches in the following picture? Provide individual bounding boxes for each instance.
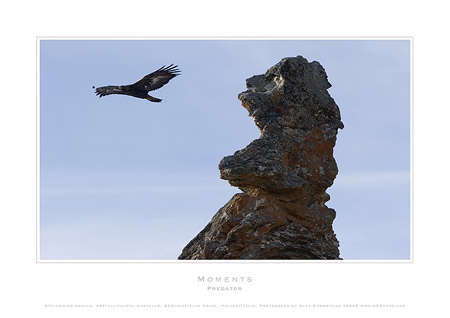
[179,56,344,259]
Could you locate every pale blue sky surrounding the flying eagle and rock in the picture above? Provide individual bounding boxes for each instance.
[39,39,410,260]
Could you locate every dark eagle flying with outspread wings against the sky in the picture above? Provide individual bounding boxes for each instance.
[92,64,180,103]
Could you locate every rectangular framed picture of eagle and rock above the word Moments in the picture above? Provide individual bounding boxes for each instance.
[37,37,412,262]
